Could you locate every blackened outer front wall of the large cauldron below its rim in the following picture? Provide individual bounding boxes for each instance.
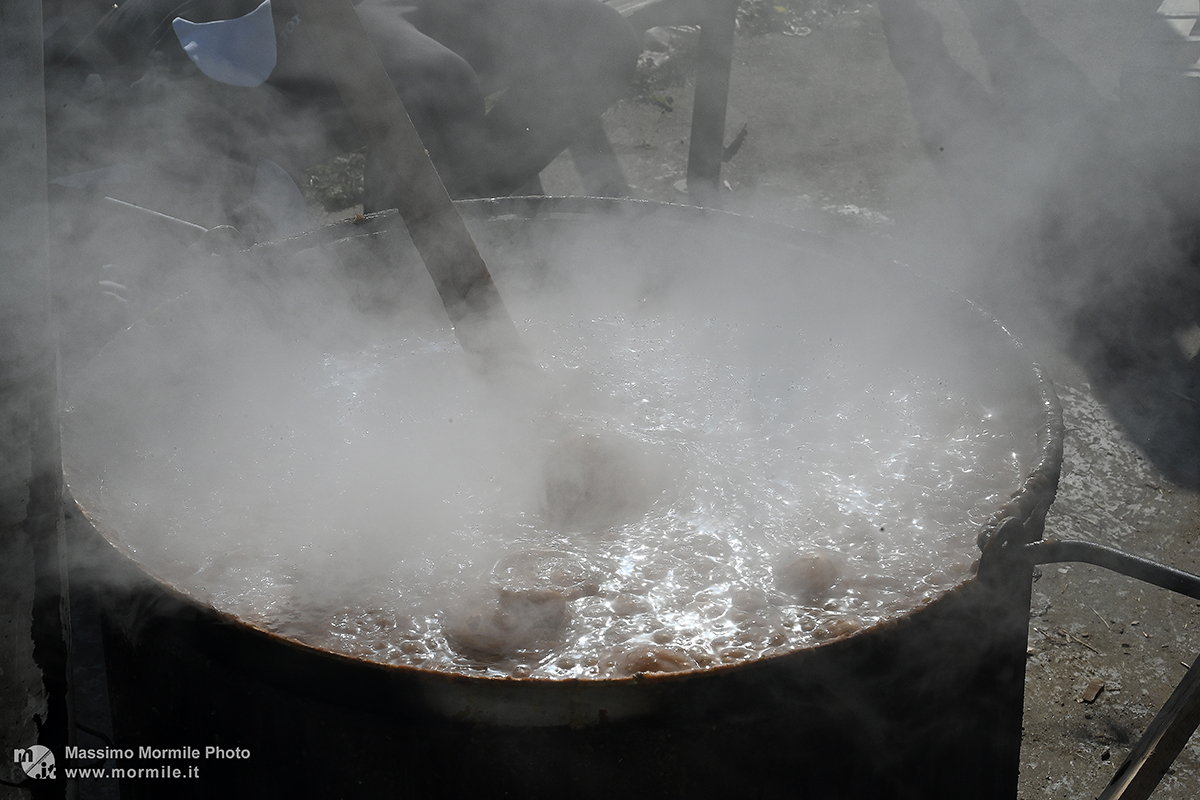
[88,534,1030,799]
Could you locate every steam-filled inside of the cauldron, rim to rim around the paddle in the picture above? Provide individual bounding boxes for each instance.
[58,203,1039,678]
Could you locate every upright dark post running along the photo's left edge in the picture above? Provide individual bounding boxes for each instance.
[0,0,77,799]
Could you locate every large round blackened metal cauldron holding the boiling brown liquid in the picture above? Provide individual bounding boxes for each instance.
[65,199,1061,800]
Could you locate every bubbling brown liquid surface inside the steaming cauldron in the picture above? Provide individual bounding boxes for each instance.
[79,314,1028,679]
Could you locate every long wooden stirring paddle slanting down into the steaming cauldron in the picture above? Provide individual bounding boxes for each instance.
[279,0,662,542]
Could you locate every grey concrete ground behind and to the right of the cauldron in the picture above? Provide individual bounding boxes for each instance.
[544,0,1200,800]
